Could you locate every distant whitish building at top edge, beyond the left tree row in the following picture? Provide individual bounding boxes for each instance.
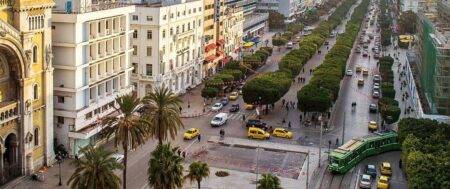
[257,0,304,19]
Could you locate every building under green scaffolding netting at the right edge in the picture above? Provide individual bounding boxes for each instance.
[418,1,450,115]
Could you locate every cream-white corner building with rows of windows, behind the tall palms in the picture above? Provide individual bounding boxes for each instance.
[131,0,204,97]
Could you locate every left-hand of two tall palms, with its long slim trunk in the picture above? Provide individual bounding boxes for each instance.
[102,95,150,189]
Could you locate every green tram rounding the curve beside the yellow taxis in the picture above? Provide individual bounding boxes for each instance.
[328,131,400,174]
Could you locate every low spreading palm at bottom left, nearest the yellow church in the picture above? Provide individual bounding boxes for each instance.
[67,145,123,189]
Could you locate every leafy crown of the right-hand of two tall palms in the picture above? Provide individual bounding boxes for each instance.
[143,86,184,145]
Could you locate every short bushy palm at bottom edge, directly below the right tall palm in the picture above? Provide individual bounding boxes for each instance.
[147,143,183,189]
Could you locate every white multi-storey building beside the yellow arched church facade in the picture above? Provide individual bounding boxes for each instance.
[52,0,135,155]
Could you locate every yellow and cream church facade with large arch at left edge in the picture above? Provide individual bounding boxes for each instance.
[0,0,54,185]
